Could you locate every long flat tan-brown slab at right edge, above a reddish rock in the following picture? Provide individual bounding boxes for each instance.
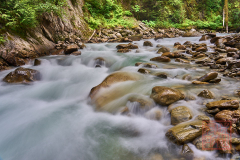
[206,100,239,109]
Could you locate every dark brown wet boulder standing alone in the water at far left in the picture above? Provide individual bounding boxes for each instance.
[3,67,41,84]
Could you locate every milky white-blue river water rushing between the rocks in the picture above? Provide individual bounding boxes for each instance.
[0,37,239,160]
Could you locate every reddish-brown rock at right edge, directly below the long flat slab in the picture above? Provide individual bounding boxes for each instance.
[215,110,240,123]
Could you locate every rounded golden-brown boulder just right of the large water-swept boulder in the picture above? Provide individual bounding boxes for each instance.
[150,86,185,106]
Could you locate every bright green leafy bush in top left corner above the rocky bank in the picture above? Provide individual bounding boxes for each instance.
[0,0,66,31]
